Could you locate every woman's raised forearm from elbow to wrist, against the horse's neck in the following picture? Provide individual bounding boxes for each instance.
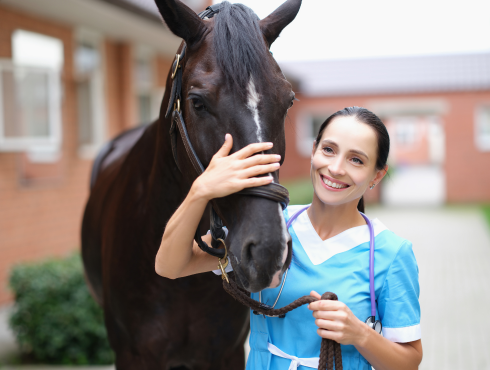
[155,186,208,279]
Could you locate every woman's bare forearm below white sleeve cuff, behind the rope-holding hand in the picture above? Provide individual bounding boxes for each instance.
[355,326,422,370]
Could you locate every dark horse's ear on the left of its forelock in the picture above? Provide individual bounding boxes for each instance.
[155,0,207,46]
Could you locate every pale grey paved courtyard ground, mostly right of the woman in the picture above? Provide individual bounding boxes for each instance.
[0,207,490,370]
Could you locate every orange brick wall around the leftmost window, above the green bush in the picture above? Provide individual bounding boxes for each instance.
[0,6,90,304]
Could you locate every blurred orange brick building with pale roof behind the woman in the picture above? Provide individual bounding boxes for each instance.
[281,53,490,205]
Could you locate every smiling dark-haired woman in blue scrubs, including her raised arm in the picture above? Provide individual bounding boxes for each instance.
[156,107,422,370]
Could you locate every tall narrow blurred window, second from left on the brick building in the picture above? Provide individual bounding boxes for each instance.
[75,30,105,159]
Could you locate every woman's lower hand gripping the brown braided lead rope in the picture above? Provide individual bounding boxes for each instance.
[308,291,372,345]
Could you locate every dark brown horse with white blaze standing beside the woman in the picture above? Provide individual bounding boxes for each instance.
[82,0,301,370]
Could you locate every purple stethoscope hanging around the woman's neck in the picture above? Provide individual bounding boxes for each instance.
[254,205,383,334]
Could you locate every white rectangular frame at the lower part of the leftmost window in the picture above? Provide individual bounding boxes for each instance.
[0,58,62,152]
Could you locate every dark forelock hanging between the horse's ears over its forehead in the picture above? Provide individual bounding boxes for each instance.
[213,1,273,93]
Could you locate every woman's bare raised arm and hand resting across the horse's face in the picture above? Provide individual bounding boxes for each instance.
[155,134,281,279]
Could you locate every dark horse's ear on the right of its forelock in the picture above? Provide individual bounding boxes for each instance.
[260,0,301,47]
